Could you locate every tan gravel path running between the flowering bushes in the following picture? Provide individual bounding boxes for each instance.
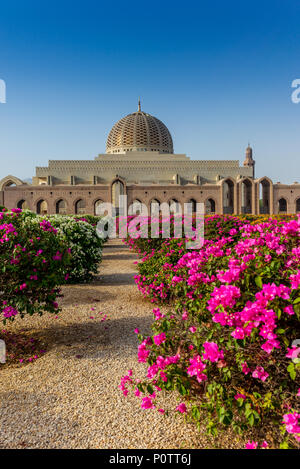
[0,240,208,449]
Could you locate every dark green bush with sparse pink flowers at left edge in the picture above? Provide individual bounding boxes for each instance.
[0,209,70,322]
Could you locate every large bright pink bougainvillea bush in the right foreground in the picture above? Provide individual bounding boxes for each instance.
[120,214,300,448]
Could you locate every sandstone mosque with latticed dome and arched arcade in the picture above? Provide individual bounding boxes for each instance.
[0,101,300,215]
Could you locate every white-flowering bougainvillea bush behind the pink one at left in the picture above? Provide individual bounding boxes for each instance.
[38,215,103,283]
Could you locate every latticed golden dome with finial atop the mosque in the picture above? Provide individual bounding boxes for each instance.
[106,102,173,153]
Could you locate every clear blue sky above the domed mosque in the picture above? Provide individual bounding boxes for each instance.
[0,0,300,183]
